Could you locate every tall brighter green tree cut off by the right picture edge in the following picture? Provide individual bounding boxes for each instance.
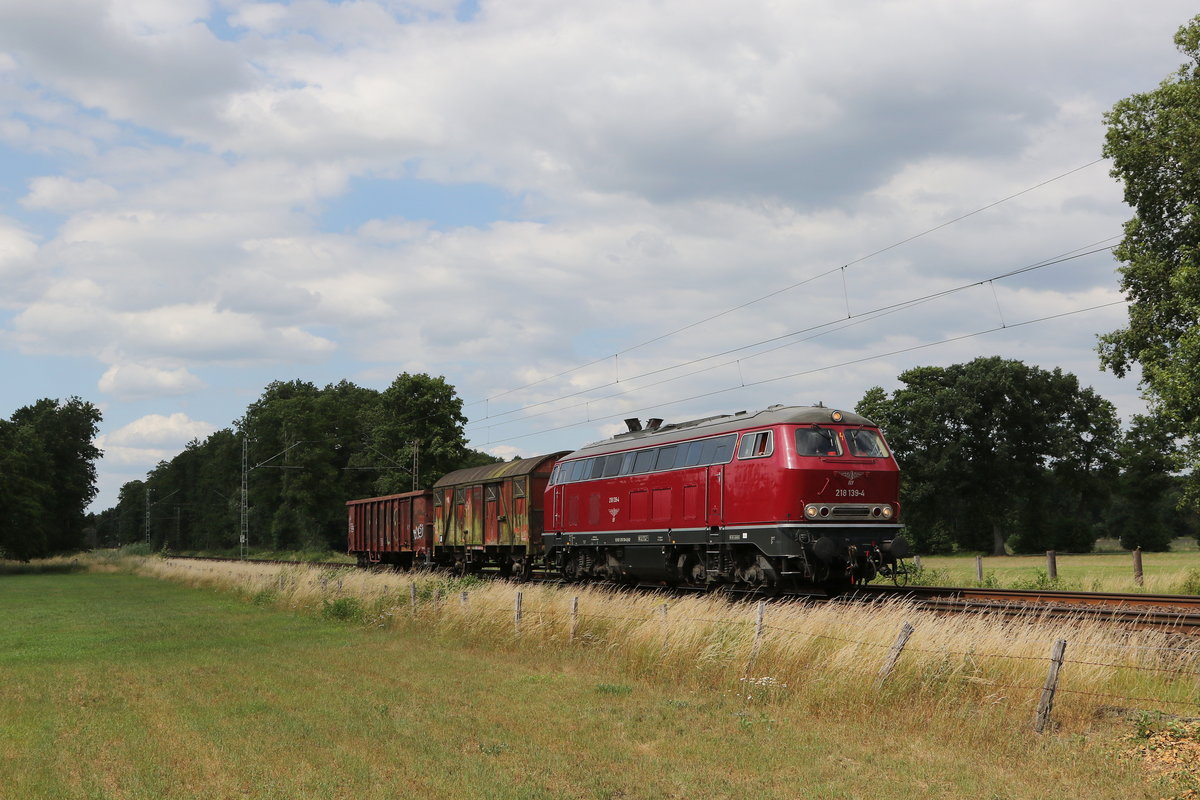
[1099,17,1200,506]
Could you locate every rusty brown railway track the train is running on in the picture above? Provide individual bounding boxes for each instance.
[162,555,1200,634]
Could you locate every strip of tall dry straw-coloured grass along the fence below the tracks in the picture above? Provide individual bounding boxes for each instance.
[102,557,1200,729]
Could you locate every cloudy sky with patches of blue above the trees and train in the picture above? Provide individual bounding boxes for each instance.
[0,0,1195,509]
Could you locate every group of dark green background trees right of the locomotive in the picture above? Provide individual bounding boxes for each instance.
[857,357,1200,555]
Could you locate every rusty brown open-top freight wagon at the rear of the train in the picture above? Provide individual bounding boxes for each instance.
[346,491,433,569]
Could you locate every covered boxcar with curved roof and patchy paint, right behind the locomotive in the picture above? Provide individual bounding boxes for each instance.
[433,451,566,578]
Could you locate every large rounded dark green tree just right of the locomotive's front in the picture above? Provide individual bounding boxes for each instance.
[857,357,1118,555]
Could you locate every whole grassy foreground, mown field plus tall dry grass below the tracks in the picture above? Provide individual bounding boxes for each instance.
[0,559,1196,799]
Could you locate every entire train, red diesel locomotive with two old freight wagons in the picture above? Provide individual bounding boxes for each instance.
[347,405,908,590]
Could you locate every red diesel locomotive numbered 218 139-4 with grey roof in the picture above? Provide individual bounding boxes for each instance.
[544,405,907,588]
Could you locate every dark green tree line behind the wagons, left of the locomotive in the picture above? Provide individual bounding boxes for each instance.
[88,373,498,551]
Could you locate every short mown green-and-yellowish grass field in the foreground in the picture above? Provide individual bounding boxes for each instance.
[0,572,1185,800]
